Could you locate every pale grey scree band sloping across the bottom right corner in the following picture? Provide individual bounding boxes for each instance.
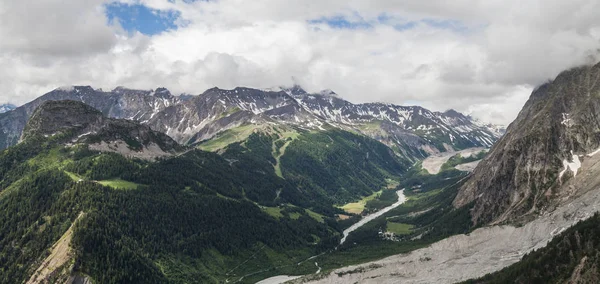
[295,181,600,283]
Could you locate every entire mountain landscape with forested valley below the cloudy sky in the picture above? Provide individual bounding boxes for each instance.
[0,64,600,283]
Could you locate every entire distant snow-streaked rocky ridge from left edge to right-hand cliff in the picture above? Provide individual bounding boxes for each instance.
[0,86,502,160]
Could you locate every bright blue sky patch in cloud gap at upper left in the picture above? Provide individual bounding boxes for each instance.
[106,3,179,35]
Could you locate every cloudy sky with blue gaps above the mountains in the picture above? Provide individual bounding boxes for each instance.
[0,0,600,124]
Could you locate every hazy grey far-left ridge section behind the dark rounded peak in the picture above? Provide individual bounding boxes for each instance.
[0,86,182,148]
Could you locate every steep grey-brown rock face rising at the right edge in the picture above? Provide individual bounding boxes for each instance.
[454,64,600,224]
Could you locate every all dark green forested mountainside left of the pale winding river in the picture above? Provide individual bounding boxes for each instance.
[0,122,405,283]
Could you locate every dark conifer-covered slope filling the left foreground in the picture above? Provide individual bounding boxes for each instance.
[0,139,336,283]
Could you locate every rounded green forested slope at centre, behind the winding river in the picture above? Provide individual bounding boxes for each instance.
[281,130,410,204]
